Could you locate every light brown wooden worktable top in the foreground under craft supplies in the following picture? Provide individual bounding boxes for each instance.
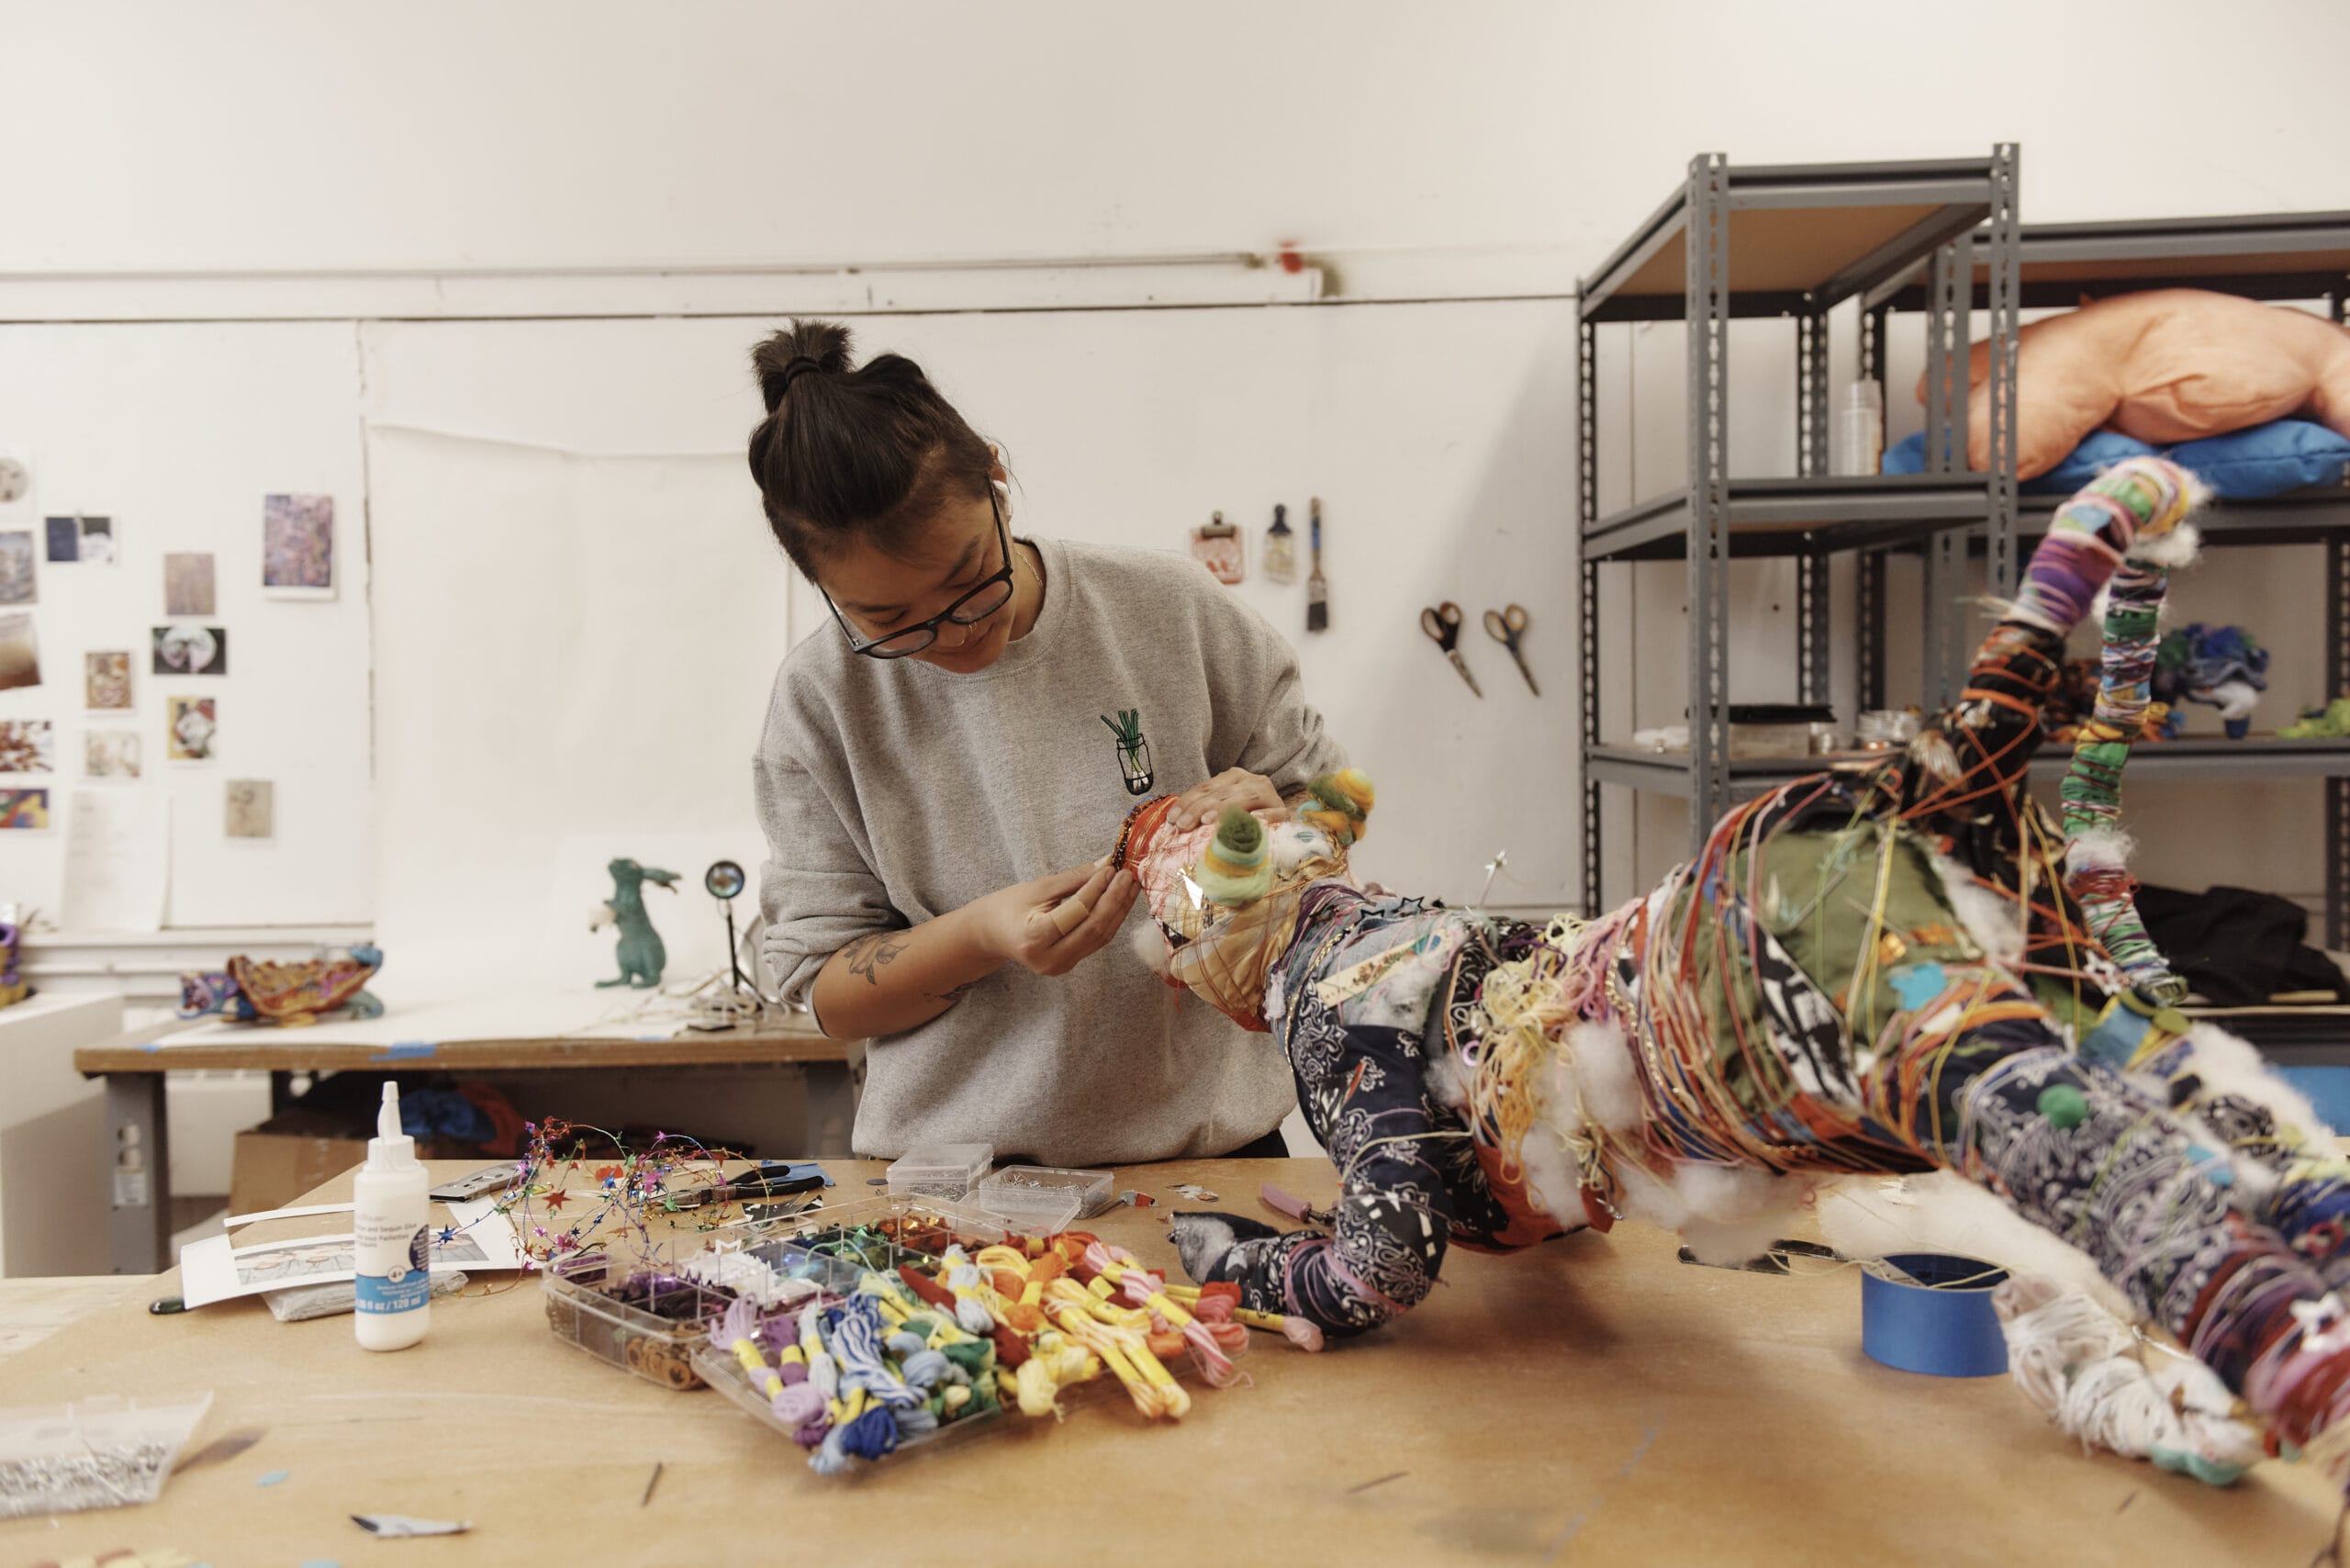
[0,1161,2336,1568]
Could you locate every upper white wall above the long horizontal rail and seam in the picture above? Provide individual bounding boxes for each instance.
[0,0,2350,940]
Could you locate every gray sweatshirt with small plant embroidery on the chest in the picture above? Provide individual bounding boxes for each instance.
[756,538,1344,1164]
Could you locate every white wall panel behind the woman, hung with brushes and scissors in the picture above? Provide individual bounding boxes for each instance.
[366,301,1579,994]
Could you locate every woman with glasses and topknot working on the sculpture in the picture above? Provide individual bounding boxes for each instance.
[750,322,1344,1164]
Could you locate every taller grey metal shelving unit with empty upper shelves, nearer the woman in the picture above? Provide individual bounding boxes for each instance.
[1577,146,2019,914]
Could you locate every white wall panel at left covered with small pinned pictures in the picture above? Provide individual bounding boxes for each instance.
[0,322,374,926]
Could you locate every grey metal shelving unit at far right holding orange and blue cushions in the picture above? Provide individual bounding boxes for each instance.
[1852,211,2350,947]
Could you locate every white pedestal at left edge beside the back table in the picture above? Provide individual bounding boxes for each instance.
[0,992,122,1276]
